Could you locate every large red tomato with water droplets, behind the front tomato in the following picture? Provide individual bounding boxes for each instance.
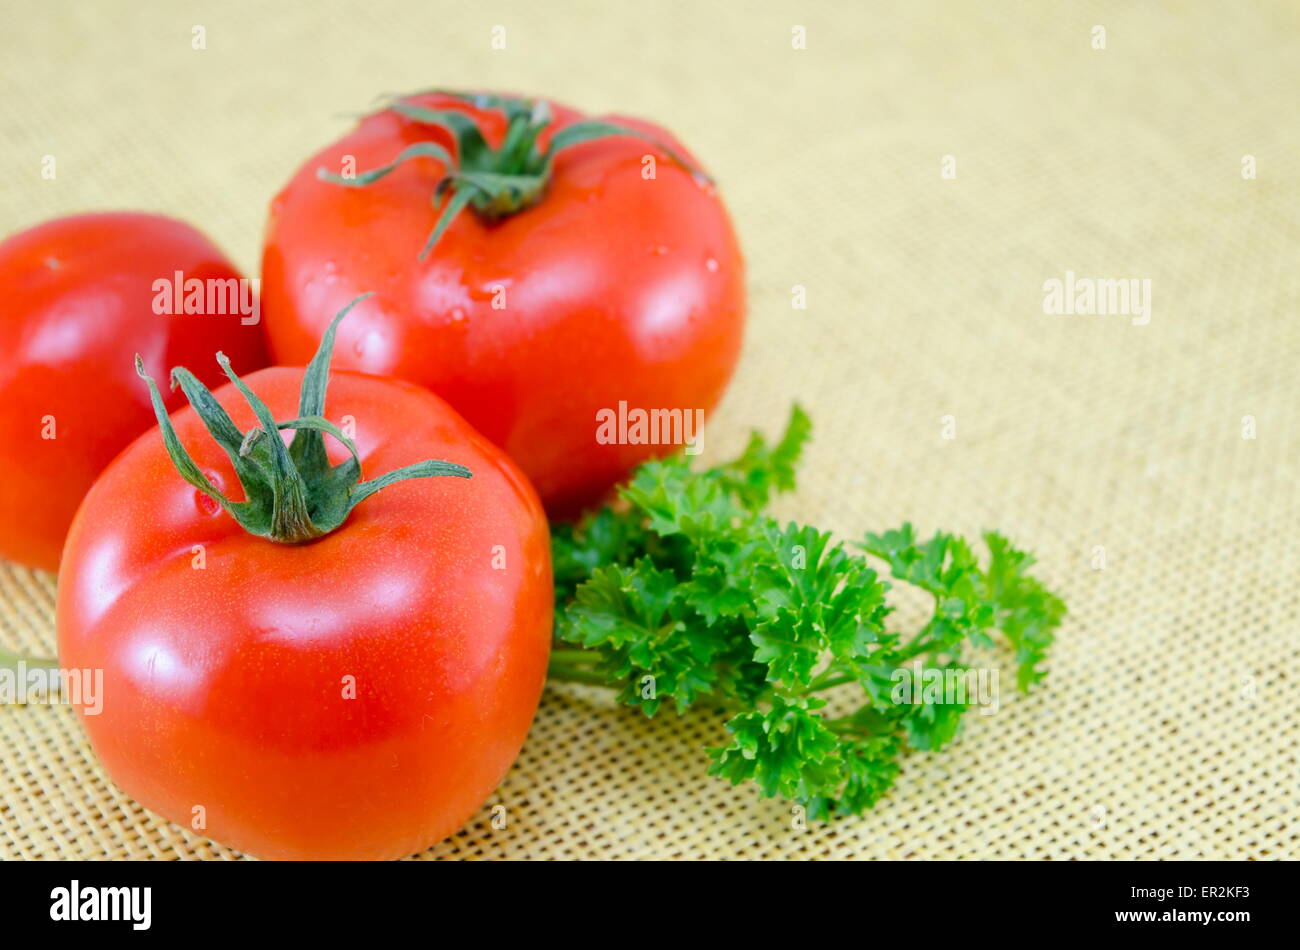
[263,94,745,516]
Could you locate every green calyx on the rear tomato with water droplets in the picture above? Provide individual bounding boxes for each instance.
[316,90,712,261]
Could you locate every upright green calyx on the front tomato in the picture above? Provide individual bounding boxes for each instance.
[135,294,471,545]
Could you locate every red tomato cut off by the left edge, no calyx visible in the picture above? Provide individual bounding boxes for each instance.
[0,213,267,571]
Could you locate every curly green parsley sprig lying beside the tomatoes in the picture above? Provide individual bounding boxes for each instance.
[551,407,1065,817]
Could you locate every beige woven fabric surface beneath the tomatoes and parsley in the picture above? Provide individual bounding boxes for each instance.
[0,0,1300,859]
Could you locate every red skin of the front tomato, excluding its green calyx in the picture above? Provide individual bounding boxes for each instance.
[57,368,553,859]
